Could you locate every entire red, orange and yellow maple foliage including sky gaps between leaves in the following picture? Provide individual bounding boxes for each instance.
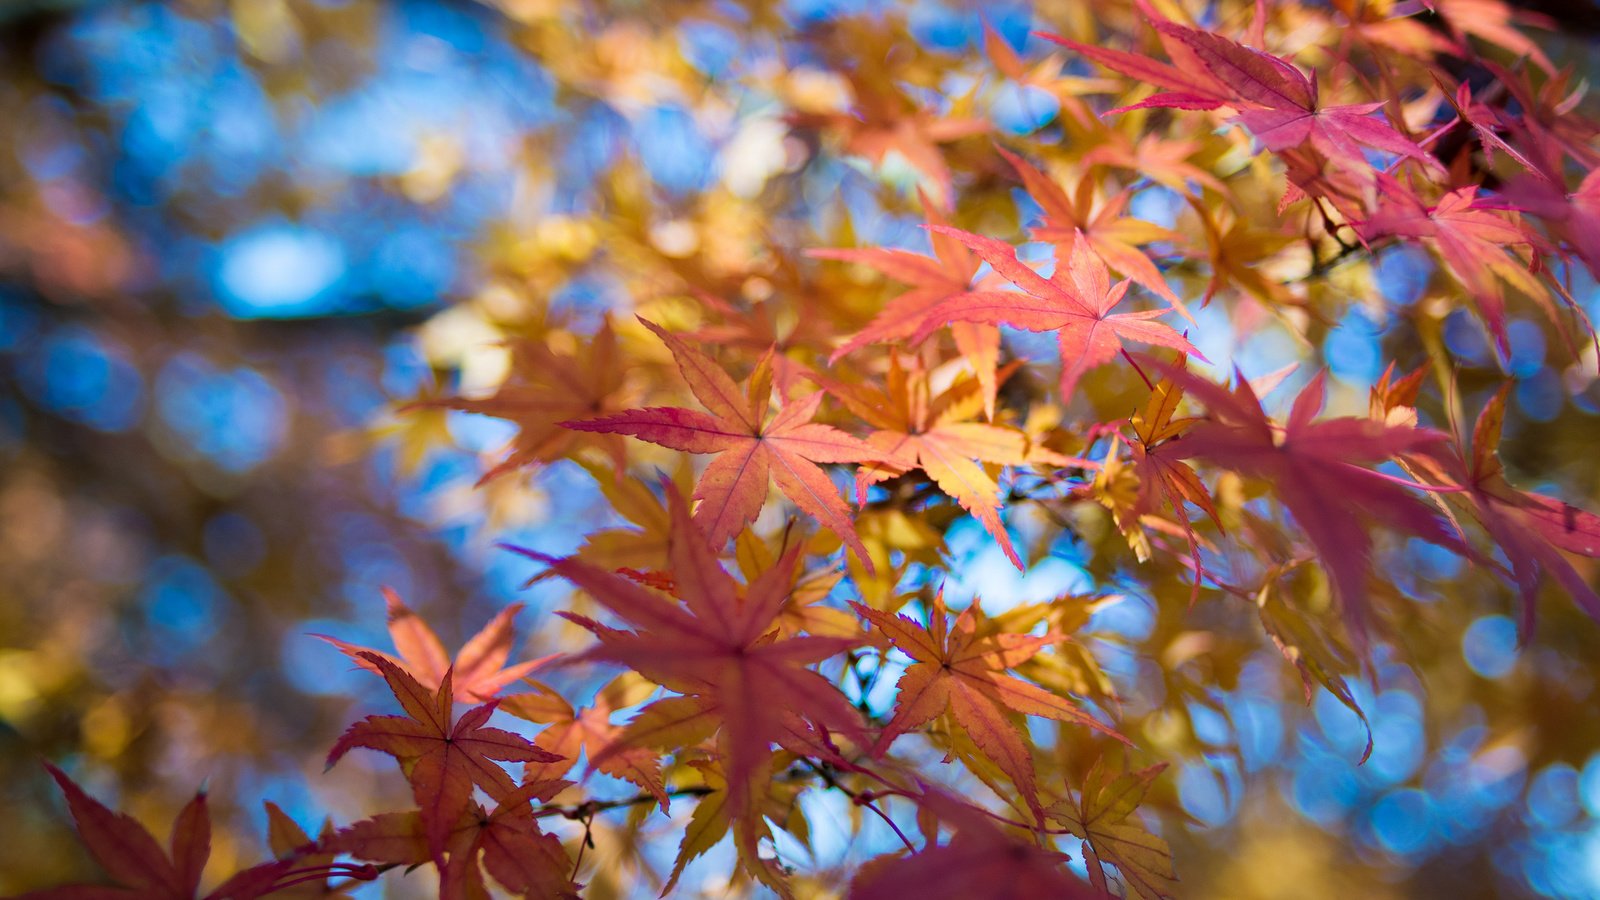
[9,0,1600,900]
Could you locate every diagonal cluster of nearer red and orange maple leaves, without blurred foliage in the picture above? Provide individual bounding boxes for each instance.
[21,0,1600,898]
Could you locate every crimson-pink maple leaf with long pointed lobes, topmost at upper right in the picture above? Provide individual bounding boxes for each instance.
[1043,21,1440,171]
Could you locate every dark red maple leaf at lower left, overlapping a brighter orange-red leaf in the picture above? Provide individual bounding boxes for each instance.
[328,650,560,857]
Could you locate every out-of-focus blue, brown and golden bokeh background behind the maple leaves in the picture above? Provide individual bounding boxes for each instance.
[0,0,1600,897]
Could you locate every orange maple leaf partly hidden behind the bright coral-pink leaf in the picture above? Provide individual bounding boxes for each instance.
[806,190,1000,420]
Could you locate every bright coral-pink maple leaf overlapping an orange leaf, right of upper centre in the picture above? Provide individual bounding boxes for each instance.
[922,226,1205,402]
